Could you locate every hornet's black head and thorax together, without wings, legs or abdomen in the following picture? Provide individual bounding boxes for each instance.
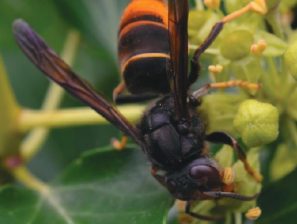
[139,95,223,200]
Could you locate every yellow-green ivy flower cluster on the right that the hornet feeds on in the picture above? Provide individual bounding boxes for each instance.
[180,0,297,223]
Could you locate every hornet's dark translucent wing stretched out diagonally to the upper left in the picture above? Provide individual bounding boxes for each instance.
[13,20,142,146]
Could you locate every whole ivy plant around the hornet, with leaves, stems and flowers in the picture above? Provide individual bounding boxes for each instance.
[0,0,297,224]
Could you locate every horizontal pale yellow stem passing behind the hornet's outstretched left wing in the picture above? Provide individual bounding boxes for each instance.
[19,105,144,133]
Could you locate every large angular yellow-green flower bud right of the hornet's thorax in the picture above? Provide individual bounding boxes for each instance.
[233,100,279,147]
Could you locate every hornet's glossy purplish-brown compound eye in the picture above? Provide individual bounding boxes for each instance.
[190,165,221,188]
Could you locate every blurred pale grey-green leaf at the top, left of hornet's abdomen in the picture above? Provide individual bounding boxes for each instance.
[53,0,129,58]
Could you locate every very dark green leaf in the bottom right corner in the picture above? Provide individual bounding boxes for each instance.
[258,167,297,224]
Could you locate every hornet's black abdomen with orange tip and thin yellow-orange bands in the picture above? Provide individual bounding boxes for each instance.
[118,0,170,94]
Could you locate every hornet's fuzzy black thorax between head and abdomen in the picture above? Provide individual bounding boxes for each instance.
[140,95,205,171]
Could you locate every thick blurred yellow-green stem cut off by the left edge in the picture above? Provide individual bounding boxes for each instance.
[0,57,21,156]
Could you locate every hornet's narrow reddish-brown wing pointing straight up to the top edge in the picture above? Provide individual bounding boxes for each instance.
[168,0,189,119]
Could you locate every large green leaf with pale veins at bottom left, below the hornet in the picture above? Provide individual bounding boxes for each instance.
[0,148,172,224]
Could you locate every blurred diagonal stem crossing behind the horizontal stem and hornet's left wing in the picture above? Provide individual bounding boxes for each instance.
[20,30,80,163]
